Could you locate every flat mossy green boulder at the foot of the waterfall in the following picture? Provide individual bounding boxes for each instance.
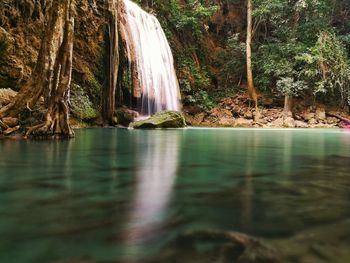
[131,111,186,129]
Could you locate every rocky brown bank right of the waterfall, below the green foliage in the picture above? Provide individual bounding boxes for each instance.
[185,93,350,129]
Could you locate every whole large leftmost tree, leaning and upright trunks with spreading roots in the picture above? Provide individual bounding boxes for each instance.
[0,0,75,138]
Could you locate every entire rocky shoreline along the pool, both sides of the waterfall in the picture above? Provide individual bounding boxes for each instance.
[0,89,350,139]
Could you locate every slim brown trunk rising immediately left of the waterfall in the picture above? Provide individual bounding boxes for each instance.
[102,0,119,125]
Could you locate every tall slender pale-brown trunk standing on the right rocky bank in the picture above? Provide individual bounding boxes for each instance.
[246,0,258,114]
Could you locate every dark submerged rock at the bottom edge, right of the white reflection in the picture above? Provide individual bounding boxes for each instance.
[157,230,282,263]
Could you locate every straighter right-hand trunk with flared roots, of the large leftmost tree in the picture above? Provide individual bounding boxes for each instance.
[26,0,75,138]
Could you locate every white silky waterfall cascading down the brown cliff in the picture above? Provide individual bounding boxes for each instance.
[119,0,180,115]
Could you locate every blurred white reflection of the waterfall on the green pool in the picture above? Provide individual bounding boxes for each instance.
[126,131,180,256]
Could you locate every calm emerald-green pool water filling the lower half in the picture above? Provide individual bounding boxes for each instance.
[0,129,350,263]
